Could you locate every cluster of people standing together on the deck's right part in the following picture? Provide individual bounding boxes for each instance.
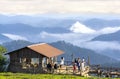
[73,58,85,73]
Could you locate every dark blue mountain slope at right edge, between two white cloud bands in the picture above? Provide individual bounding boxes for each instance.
[92,31,120,42]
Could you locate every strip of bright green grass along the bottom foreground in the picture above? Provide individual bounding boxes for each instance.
[0,73,120,79]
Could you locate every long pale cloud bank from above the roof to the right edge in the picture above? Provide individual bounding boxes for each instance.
[38,32,120,51]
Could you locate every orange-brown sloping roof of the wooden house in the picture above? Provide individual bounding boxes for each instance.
[27,43,63,57]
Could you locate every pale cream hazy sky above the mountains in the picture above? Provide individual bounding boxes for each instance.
[0,0,120,14]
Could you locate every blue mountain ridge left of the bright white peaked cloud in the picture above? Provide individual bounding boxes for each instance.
[0,23,69,35]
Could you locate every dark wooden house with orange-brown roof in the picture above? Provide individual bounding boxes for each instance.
[7,43,63,73]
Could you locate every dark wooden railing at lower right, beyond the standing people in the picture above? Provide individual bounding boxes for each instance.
[89,65,120,77]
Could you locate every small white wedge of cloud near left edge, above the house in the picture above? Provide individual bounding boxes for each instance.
[2,33,27,40]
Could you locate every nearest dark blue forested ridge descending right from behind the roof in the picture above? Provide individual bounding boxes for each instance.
[51,41,116,64]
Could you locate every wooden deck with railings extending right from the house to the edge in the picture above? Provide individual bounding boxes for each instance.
[43,66,120,77]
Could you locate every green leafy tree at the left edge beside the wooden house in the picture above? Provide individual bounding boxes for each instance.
[0,46,7,71]
